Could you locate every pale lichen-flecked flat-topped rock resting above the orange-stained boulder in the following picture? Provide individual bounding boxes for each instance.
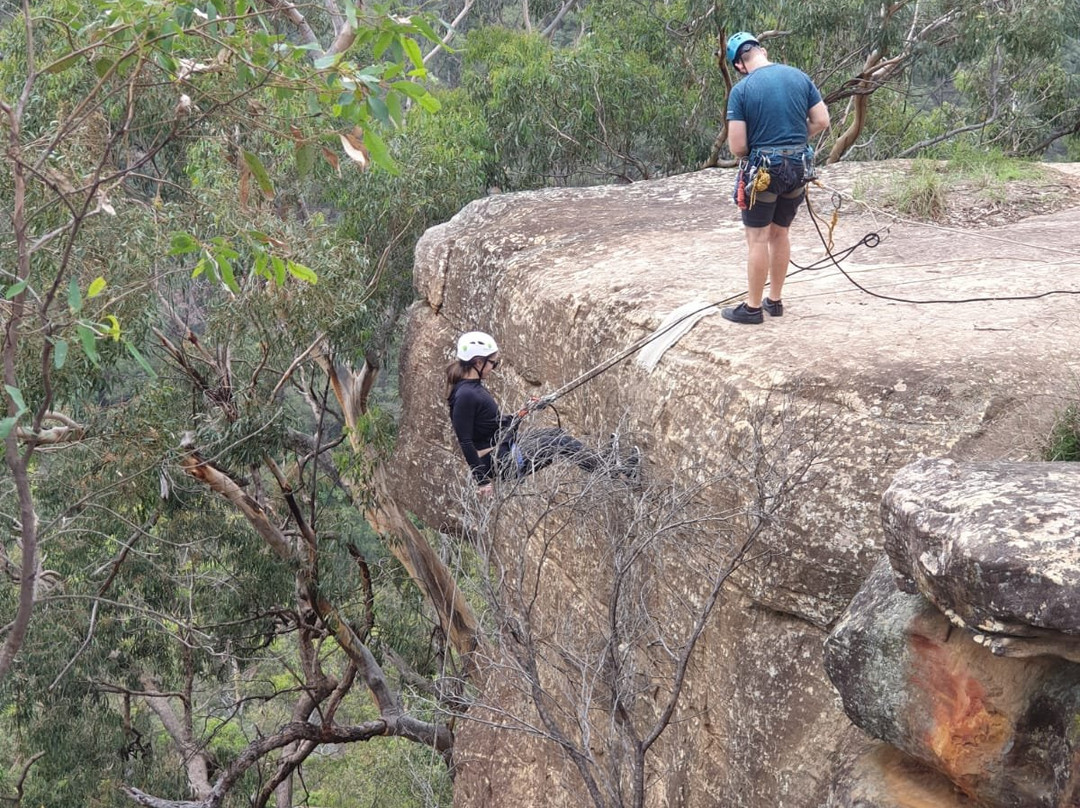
[881,460,1080,661]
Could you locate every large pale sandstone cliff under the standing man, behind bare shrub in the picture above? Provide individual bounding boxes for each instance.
[394,160,1080,808]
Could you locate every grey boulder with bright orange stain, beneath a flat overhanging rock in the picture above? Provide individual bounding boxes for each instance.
[825,557,1080,808]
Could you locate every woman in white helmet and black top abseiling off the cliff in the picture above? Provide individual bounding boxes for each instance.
[446,331,638,494]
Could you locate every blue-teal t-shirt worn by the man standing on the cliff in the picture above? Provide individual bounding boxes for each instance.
[728,64,821,150]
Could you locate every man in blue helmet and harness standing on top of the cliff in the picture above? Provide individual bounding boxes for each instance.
[720,31,829,324]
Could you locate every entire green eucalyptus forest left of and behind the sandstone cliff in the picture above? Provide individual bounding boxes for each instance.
[0,0,1080,808]
